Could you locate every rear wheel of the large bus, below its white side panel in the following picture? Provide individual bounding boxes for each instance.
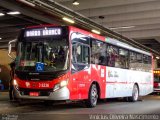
[129,84,139,102]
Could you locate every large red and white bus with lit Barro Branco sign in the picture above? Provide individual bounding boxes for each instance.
[9,25,153,107]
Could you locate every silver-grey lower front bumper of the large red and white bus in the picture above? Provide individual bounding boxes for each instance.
[14,87,70,100]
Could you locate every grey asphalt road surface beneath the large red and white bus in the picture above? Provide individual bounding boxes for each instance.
[0,93,160,120]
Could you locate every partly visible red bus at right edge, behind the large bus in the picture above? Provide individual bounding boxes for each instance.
[154,69,160,93]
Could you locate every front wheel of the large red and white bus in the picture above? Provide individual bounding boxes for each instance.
[86,84,98,108]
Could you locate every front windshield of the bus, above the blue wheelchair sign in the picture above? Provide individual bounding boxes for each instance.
[16,38,69,72]
